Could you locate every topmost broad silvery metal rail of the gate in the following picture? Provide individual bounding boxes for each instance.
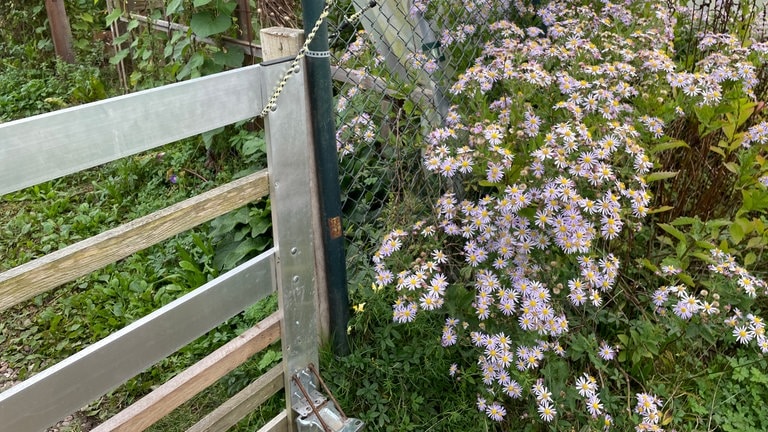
[0,65,264,195]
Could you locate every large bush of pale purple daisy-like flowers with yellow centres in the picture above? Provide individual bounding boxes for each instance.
[339,0,768,430]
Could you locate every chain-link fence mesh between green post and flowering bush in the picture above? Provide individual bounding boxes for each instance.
[329,0,536,289]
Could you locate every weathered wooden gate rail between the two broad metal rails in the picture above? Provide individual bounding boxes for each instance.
[0,170,269,310]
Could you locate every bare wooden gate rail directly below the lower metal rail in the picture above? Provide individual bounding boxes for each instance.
[93,311,282,432]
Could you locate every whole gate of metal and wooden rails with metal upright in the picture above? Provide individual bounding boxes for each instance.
[0,58,322,432]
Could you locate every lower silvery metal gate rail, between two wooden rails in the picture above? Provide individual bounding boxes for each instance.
[0,249,275,432]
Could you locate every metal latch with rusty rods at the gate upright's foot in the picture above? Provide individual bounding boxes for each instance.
[291,363,365,432]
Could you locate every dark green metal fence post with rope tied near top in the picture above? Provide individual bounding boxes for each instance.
[301,0,349,355]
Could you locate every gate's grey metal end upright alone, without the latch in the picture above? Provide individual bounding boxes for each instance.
[262,62,319,430]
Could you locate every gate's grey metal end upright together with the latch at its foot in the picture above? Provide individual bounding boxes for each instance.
[262,58,364,432]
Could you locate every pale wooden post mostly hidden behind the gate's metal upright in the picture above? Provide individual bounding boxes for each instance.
[260,27,330,342]
